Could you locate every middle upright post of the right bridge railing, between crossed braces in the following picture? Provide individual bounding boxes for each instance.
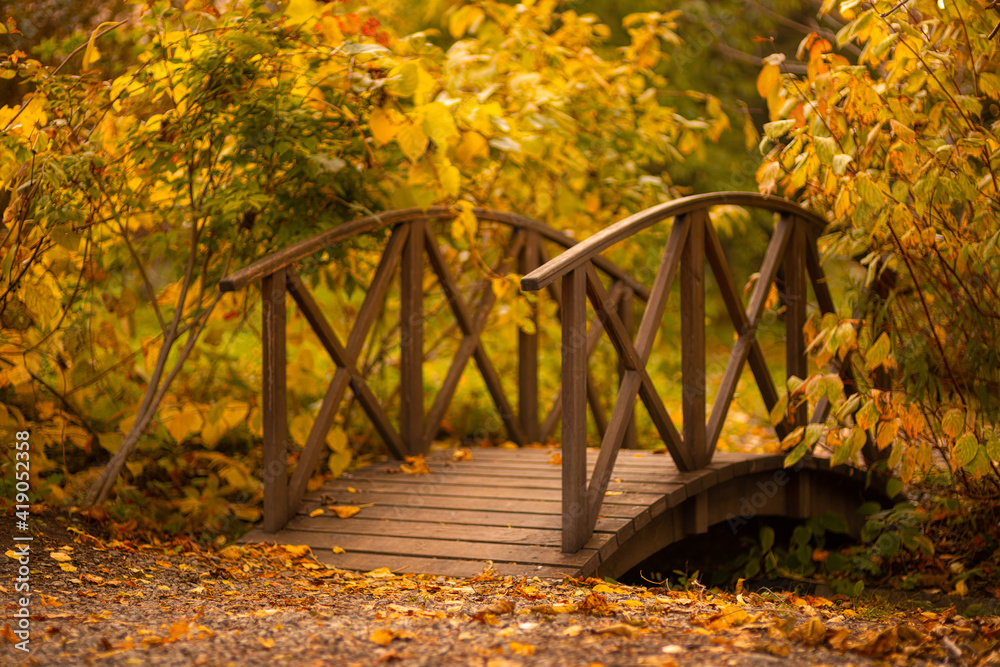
[681,214,709,468]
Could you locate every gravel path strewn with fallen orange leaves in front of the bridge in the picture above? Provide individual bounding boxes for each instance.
[0,515,1000,667]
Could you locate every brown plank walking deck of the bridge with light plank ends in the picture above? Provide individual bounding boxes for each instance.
[243,448,844,578]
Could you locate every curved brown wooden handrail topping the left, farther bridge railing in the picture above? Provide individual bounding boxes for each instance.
[219,206,649,297]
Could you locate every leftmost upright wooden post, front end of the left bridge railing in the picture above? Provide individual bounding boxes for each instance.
[260,269,288,533]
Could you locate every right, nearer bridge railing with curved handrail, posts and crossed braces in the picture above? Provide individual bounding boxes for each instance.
[521,192,848,552]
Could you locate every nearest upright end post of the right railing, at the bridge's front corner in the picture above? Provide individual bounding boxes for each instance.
[562,262,591,553]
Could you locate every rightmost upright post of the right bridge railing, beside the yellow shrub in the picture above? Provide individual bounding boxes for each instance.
[784,218,809,427]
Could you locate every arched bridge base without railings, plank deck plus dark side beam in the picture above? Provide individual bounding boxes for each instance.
[244,448,884,578]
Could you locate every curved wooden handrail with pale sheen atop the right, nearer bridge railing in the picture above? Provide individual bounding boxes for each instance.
[521,192,827,292]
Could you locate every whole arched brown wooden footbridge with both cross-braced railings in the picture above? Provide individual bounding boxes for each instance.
[221,192,884,576]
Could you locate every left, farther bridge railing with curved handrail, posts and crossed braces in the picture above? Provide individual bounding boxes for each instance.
[219,207,649,532]
